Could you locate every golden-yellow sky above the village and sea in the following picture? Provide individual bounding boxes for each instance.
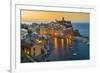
[21,10,89,23]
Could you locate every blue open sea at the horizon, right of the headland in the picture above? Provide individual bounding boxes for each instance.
[72,23,90,37]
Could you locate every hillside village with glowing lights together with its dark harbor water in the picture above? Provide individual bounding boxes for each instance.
[21,17,89,63]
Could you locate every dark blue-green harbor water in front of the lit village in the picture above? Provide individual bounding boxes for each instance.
[46,39,89,61]
